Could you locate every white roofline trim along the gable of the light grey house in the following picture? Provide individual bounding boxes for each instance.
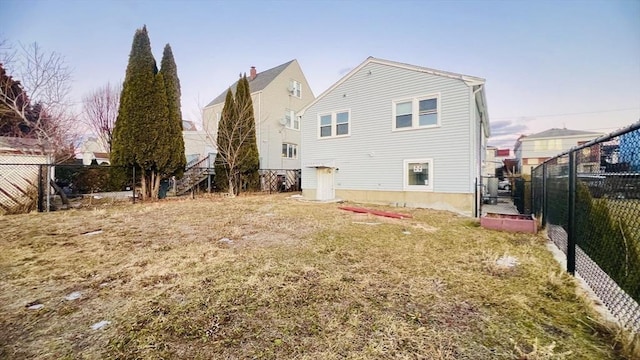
[298,56,488,116]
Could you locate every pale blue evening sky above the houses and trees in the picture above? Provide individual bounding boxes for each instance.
[0,0,640,148]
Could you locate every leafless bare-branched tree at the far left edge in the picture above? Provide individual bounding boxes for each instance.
[0,41,77,162]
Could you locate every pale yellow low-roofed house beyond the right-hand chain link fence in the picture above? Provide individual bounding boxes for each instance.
[513,128,604,175]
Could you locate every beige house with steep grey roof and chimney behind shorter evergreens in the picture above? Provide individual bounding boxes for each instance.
[203,60,314,169]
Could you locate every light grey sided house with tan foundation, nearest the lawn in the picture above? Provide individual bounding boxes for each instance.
[300,57,489,215]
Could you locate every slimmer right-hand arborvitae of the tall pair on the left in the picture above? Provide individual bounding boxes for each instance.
[160,44,187,177]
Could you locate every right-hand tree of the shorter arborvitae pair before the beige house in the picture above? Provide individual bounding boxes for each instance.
[236,74,260,191]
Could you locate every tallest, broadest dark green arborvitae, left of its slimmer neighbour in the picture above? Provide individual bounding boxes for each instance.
[111,26,169,200]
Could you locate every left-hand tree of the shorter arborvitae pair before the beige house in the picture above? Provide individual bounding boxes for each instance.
[214,89,236,195]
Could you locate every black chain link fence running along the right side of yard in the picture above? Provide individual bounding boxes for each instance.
[532,122,640,332]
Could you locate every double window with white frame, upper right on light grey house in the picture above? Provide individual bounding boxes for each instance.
[393,95,440,130]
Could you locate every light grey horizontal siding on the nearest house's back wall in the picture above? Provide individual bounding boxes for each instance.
[301,63,477,193]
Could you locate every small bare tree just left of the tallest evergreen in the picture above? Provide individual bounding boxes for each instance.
[82,83,122,152]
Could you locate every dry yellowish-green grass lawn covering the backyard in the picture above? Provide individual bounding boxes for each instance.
[0,195,630,359]
